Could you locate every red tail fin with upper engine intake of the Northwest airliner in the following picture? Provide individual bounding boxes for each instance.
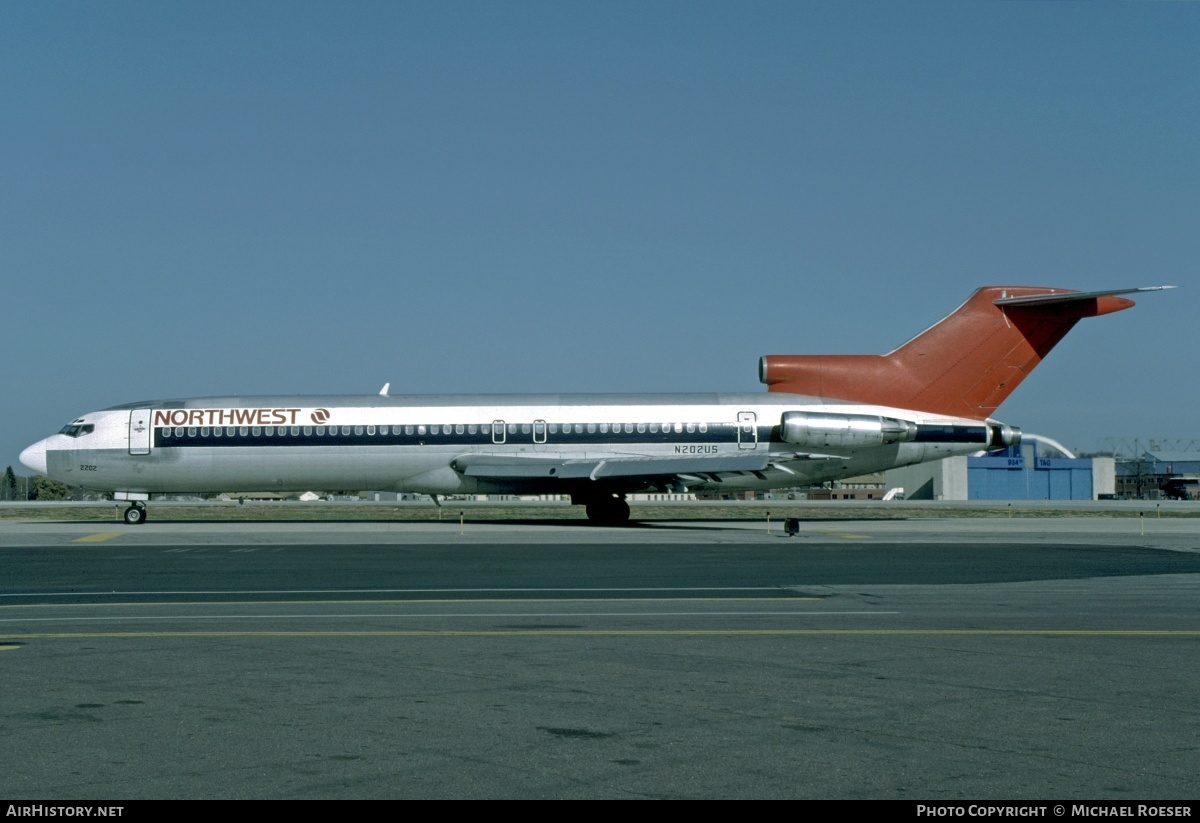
[758,286,1169,419]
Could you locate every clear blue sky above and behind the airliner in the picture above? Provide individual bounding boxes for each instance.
[0,1,1200,468]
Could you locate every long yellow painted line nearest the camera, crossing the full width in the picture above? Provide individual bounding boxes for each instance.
[2,629,1200,642]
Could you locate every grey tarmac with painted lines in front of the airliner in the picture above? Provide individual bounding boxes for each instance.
[0,516,1200,801]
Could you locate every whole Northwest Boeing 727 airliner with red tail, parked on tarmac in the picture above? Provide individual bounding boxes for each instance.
[20,287,1170,523]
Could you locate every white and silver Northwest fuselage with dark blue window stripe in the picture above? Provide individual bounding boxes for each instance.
[22,394,997,500]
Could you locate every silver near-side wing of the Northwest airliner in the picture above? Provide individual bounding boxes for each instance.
[450,451,778,480]
